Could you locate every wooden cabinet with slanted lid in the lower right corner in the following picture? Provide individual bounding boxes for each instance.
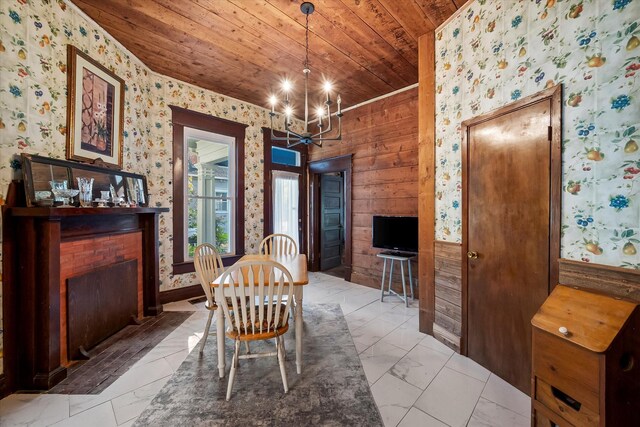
[531,286,640,427]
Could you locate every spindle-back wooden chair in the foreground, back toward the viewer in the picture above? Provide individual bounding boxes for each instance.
[220,261,293,400]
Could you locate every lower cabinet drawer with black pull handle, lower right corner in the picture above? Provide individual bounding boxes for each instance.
[534,378,600,427]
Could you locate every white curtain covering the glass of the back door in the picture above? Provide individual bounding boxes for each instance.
[272,171,302,252]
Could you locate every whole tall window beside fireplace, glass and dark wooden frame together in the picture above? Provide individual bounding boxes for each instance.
[171,106,246,274]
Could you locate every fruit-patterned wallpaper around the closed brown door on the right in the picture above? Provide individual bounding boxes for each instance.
[436,0,640,269]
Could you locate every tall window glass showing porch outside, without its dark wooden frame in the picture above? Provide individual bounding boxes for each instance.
[184,127,236,259]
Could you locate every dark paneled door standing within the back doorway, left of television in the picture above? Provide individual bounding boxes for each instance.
[320,174,344,270]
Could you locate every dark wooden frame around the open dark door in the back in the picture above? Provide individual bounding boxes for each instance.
[308,154,353,282]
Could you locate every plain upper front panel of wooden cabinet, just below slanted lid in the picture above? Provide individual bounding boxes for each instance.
[532,329,601,414]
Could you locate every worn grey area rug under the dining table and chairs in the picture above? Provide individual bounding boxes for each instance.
[134,304,383,427]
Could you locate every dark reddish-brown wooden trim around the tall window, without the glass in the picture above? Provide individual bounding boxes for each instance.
[169,105,248,274]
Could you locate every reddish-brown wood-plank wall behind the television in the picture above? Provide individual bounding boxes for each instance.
[309,89,418,290]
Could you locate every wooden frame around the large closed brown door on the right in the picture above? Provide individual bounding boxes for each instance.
[460,85,562,356]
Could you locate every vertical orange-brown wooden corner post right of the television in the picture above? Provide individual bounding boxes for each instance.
[418,32,436,334]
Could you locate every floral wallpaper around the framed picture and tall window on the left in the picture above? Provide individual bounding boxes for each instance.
[0,0,296,372]
